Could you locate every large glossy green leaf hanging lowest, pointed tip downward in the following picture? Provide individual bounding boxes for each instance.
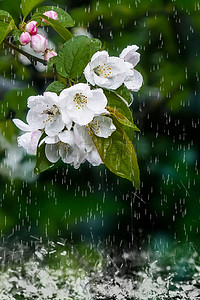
[92,123,140,189]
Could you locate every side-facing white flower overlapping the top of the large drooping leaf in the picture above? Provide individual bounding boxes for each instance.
[74,115,116,166]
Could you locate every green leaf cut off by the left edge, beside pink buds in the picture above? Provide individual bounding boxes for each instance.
[0,10,15,44]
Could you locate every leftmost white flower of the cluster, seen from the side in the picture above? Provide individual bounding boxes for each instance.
[13,119,42,155]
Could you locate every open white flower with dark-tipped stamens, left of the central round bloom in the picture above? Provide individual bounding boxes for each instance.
[27,92,71,136]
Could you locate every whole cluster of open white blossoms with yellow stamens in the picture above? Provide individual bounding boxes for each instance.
[13,45,142,168]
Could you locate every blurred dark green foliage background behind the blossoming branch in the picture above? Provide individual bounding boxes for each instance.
[0,0,200,255]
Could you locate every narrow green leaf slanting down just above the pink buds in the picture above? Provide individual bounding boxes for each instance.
[32,13,73,41]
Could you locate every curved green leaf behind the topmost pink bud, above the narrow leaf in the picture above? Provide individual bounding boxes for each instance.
[32,6,74,27]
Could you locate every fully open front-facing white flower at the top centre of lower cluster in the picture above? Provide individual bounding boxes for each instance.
[59,83,107,125]
